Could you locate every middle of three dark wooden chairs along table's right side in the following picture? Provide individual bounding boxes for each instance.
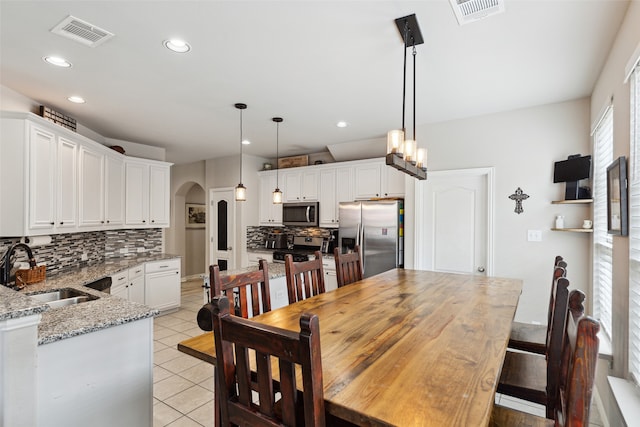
[498,277,580,418]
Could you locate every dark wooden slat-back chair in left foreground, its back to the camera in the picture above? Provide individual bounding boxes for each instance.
[206,296,325,427]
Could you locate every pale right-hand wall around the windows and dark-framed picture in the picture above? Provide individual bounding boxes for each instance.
[591,1,640,426]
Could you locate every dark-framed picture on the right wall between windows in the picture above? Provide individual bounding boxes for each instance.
[607,156,629,236]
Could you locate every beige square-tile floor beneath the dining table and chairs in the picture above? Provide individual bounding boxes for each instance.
[153,280,604,427]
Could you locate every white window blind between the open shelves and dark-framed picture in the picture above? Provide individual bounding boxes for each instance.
[593,107,613,337]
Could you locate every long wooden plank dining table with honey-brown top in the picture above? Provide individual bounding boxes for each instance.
[178,268,522,427]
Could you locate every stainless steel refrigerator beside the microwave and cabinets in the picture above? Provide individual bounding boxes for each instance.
[338,200,404,277]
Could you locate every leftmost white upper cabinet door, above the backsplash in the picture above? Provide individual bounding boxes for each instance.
[28,126,57,230]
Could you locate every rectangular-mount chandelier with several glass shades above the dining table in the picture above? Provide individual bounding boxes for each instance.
[386,14,427,180]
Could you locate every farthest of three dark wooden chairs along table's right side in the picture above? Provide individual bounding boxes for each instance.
[509,256,567,354]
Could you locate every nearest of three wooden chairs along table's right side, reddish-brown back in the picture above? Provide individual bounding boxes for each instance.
[490,306,600,427]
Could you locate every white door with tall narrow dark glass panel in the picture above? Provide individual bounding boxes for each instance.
[209,188,236,271]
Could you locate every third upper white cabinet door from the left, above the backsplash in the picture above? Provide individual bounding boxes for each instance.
[79,146,105,231]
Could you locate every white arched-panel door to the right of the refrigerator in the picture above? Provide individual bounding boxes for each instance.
[415,168,493,275]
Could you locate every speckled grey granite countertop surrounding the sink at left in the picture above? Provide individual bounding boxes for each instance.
[0,254,179,344]
